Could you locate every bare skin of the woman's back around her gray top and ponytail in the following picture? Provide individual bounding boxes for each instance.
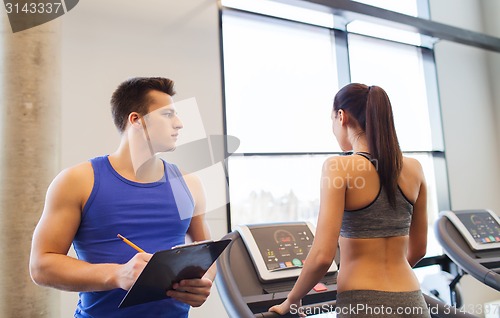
[338,155,423,292]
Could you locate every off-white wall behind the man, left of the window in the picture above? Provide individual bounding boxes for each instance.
[61,0,226,317]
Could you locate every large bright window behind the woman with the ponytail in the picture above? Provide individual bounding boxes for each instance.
[222,0,449,270]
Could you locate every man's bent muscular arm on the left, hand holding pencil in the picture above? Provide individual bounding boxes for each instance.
[30,163,151,291]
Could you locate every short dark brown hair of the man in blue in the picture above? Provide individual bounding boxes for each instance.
[111,77,175,133]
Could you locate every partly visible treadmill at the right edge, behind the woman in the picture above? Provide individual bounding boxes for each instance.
[434,210,500,299]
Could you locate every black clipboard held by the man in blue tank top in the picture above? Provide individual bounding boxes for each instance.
[118,239,231,308]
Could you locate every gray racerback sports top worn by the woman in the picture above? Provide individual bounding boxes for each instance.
[340,153,413,238]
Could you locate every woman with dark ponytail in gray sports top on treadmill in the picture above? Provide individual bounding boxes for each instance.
[270,83,430,317]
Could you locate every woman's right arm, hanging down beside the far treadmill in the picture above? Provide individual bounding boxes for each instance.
[407,160,427,267]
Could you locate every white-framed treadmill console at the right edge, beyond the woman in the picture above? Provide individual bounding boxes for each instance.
[441,210,500,251]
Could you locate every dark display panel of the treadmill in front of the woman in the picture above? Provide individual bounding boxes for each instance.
[250,225,313,271]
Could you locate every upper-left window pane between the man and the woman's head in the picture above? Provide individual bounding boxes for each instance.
[222,12,338,153]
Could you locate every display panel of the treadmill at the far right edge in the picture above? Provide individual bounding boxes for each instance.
[457,212,500,244]
